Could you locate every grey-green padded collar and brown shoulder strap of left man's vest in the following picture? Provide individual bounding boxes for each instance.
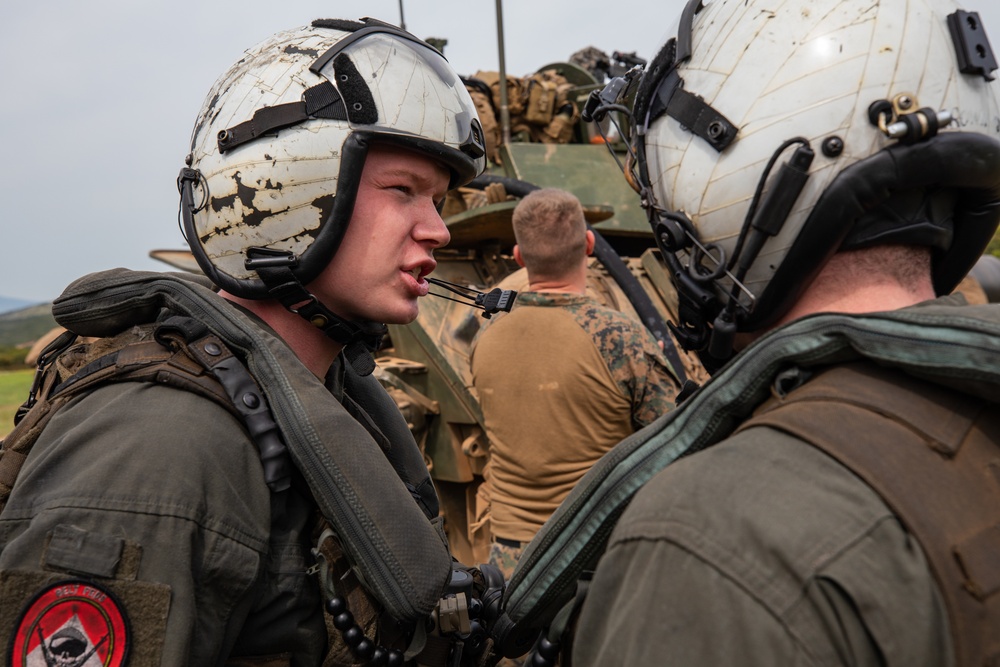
[0,269,452,622]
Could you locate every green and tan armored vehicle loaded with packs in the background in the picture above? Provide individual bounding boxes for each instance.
[150,48,1000,563]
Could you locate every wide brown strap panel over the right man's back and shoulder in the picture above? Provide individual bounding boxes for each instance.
[739,362,1000,667]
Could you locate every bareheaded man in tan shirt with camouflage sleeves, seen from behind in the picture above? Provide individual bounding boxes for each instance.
[472,190,678,578]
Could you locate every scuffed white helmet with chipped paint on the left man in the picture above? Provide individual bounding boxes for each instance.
[179,19,485,299]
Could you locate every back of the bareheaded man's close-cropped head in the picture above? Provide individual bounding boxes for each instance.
[512,188,587,278]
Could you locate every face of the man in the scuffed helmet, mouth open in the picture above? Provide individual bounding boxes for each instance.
[309,144,451,324]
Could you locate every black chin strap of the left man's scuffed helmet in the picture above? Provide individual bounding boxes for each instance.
[246,248,388,376]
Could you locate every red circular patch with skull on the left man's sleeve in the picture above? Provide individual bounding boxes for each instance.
[10,581,129,667]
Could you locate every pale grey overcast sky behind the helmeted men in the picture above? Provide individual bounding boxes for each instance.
[0,0,1000,302]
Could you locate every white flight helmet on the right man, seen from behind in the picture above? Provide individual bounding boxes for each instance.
[631,0,1000,366]
